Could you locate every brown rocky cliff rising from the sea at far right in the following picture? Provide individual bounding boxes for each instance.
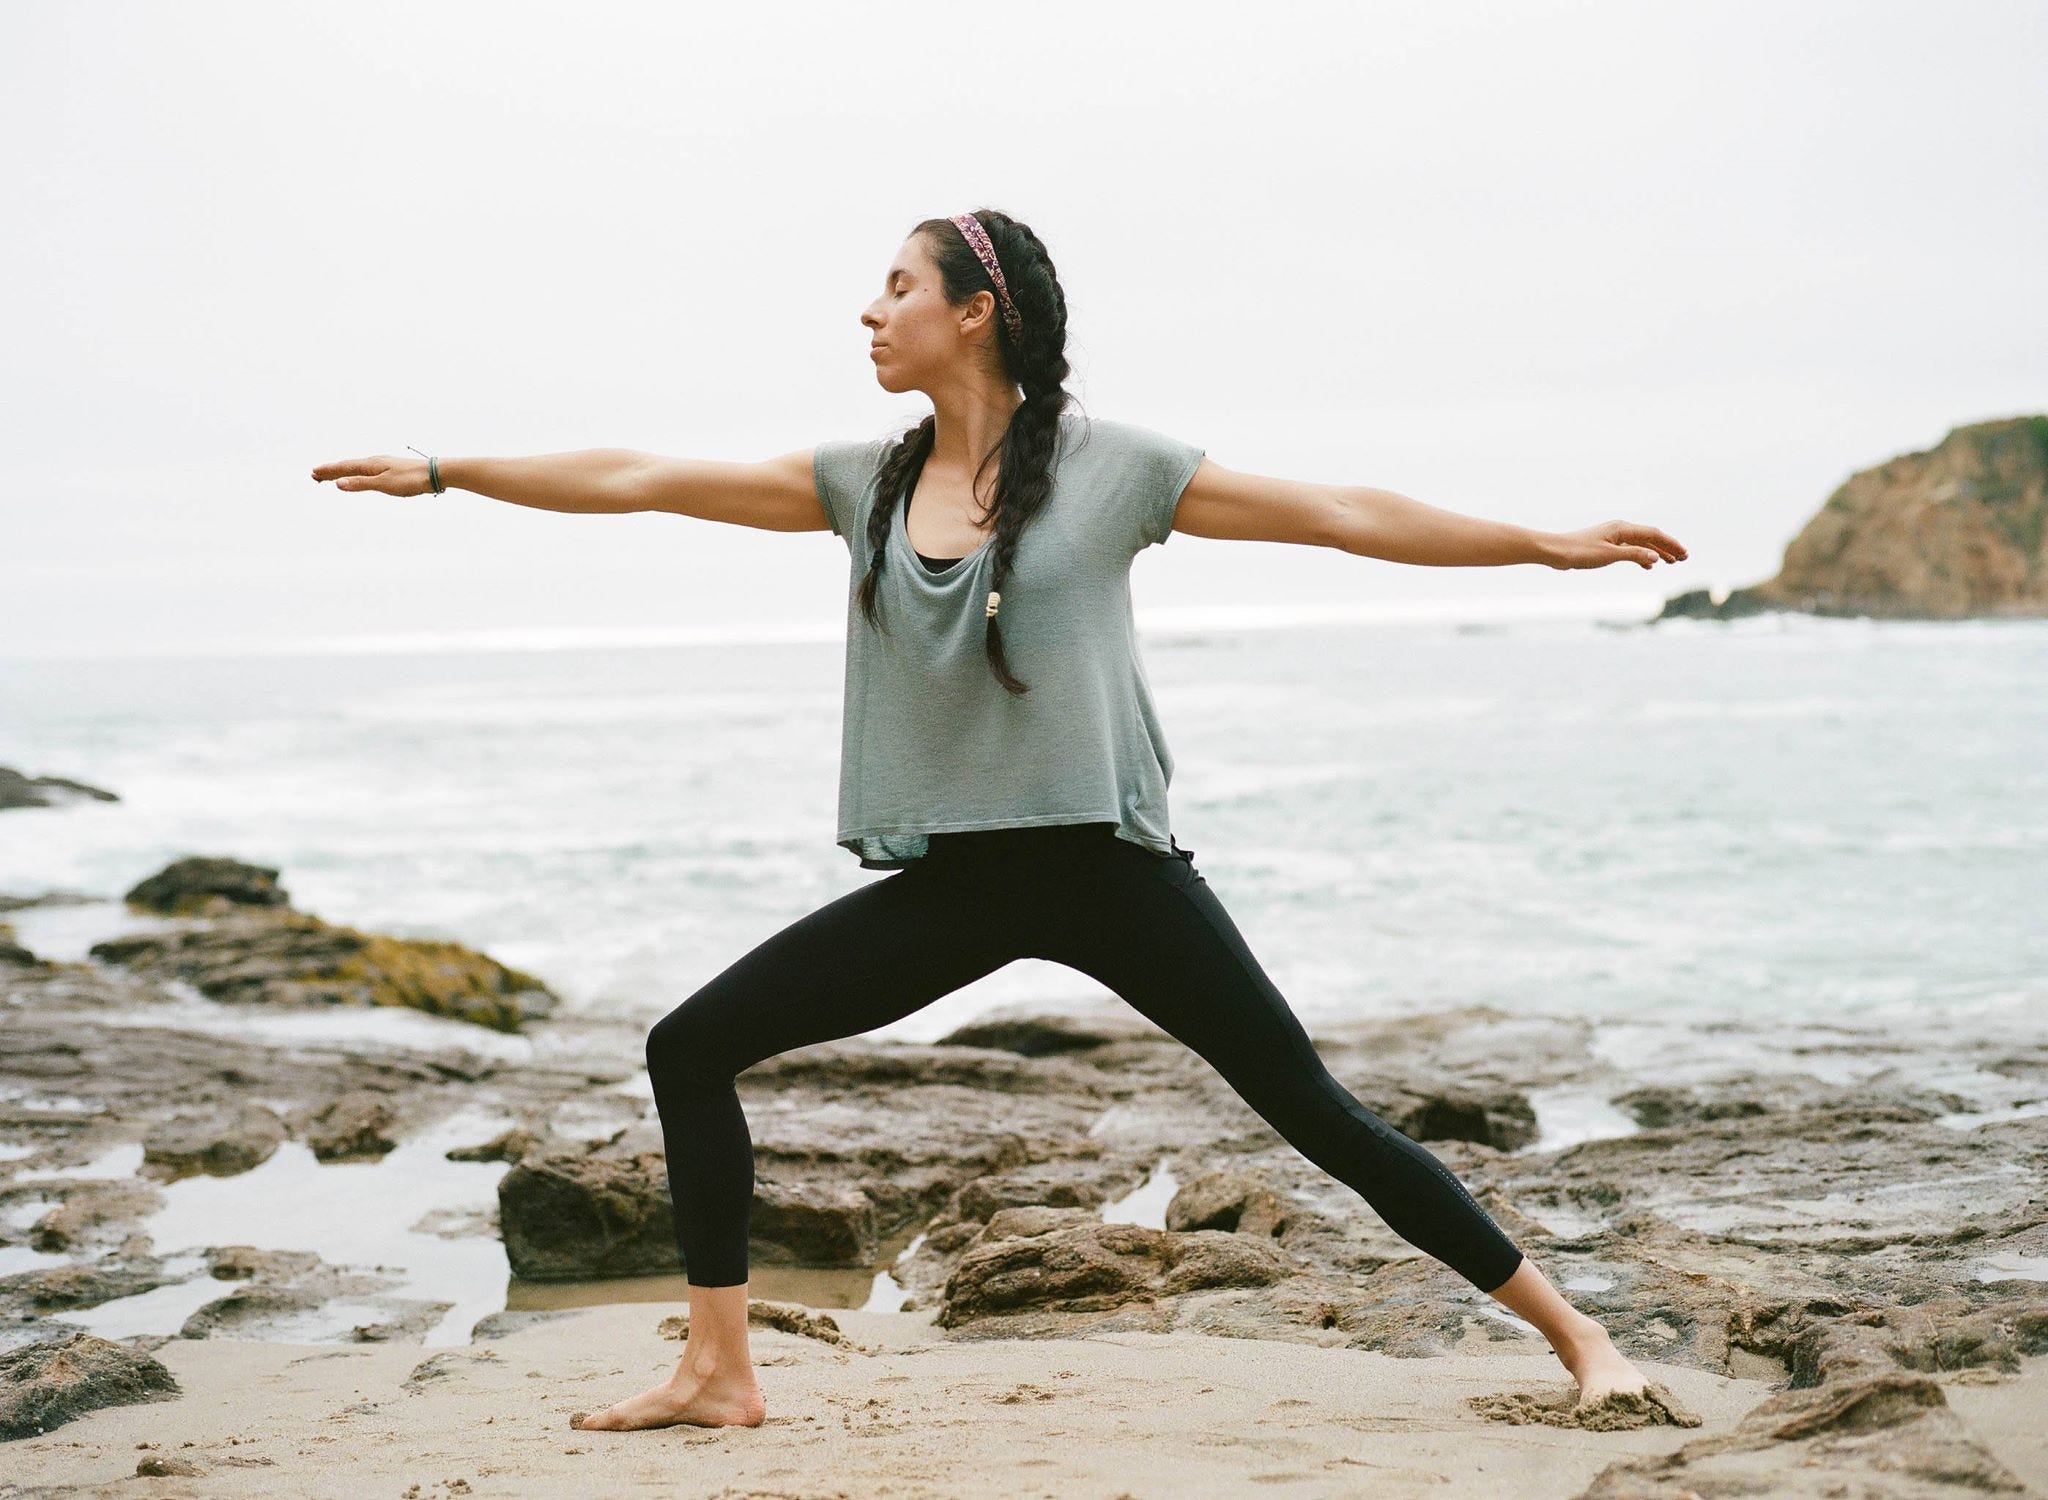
[1657,416,2048,619]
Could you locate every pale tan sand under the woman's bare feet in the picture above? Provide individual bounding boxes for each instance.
[0,1303,1835,1496]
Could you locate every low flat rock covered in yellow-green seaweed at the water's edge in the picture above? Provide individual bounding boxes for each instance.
[90,901,557,1031]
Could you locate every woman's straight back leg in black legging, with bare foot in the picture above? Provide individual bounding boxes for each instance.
[1042,840,1642,1400]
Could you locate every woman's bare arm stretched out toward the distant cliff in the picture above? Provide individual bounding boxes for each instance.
[1174,459,1686,568]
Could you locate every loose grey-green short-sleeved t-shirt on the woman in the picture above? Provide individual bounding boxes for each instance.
[815,410,1202,869]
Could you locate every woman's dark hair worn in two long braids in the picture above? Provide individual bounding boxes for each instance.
[858,209,1073,693]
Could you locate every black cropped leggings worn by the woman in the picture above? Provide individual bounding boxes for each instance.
[647,824,1522,1291]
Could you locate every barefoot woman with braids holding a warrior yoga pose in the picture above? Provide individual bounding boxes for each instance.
[313,209,1686,1430]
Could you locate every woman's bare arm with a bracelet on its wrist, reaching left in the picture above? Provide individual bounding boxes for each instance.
[313,449,831,531]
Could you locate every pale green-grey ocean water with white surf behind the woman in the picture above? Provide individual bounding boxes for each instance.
[0,615,2048,1041]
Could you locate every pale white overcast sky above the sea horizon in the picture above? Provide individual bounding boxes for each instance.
[0,0,2048,656]
